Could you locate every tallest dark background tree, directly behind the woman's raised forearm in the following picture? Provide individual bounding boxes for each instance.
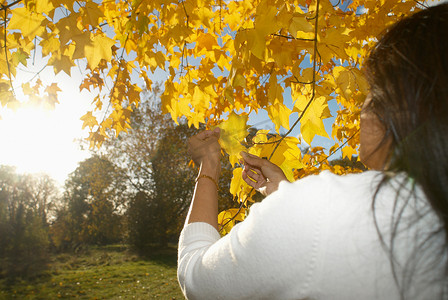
[105,92,236,252]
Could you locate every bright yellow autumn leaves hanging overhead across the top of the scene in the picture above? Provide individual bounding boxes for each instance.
[0,0,428,232]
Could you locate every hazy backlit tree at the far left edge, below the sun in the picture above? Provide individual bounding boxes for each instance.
[0,166,57,279]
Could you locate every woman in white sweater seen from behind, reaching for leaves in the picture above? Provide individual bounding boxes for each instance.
[178,4,448,300]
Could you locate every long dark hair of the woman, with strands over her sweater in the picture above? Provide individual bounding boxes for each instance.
[365,3,448,298]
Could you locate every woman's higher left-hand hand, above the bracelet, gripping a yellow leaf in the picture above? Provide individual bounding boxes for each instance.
[188,128,221,180]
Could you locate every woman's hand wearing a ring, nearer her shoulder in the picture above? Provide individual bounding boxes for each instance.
[241,152,288,196]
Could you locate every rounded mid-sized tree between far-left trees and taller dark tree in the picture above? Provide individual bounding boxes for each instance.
[52,155,126,249]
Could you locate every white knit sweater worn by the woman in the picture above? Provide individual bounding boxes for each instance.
[178,171,444,300]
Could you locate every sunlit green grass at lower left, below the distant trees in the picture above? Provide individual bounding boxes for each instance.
[0,246,184,299]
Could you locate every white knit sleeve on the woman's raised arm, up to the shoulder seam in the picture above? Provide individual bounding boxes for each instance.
[178,175,326,299]
